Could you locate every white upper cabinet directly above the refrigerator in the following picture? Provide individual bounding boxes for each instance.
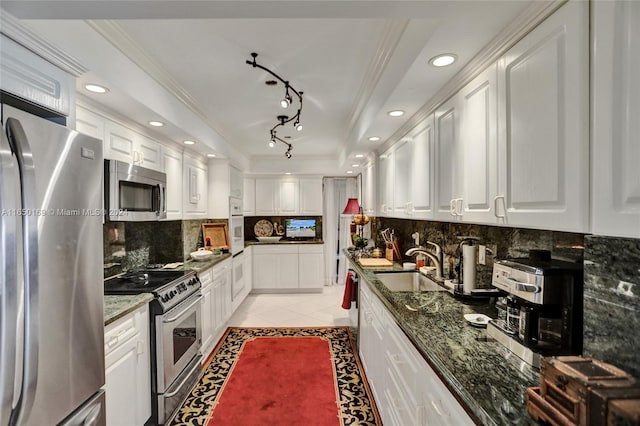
[0,34,75,116]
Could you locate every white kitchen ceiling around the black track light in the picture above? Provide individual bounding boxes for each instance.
[2,0,531,174]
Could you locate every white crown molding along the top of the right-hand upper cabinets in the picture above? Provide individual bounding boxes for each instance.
[376,0,569,154]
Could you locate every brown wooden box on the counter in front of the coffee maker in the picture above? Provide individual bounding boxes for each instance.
[540,356,636,425]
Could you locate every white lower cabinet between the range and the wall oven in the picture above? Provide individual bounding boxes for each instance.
[198,259,232,363]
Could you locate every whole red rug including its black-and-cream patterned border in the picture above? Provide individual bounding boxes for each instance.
[167,327,382,426]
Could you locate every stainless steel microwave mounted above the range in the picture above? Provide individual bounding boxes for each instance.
[104,160,167,221]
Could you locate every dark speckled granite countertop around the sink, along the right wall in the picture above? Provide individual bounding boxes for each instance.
[346,252,539,425]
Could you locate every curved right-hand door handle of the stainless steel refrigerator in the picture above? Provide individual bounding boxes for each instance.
[7,118,39,425]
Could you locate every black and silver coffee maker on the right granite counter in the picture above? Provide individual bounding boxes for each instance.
[487,250,583,367]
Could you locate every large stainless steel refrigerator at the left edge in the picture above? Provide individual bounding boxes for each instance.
[0,105,105,426]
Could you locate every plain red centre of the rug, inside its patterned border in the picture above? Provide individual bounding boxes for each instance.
[207,337,340,426]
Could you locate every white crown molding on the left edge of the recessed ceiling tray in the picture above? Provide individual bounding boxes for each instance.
[86,20,231,143]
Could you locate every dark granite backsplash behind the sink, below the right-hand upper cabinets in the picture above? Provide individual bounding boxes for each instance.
[371,217,584,288]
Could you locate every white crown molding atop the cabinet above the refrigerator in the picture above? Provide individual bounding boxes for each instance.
[0,9,88,77]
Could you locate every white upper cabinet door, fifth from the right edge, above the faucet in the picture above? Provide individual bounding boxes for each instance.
[409,116,434,219]
